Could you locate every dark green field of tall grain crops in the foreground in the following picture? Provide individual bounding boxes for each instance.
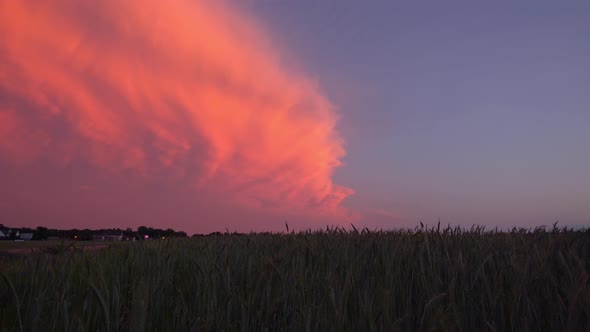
[0,229,590,331]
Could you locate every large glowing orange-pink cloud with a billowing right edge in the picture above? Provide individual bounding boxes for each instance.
[0,0,352,217]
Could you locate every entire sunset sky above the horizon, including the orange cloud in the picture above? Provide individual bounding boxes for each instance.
[0,0,590,234]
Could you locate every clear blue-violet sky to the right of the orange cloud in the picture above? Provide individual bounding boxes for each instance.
[245,0,590,227]
